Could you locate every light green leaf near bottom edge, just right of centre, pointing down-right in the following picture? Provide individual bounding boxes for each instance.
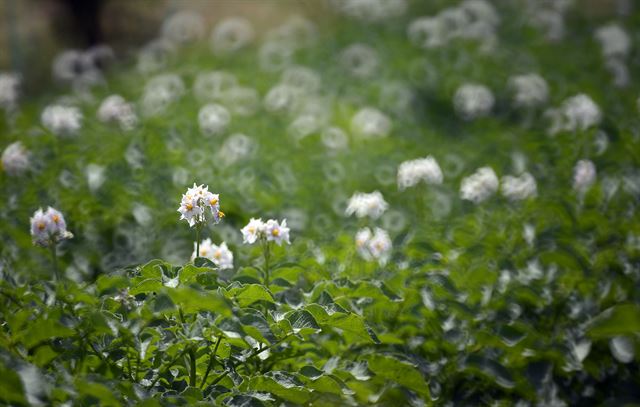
[369,355,429,398]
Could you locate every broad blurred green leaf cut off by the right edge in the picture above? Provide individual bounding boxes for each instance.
[587,304,640,338]
